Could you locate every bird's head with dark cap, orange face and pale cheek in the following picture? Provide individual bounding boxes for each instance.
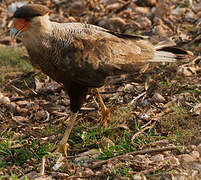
[10,4,50,38]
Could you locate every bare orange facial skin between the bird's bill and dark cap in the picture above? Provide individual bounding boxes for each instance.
[13,18,31,32]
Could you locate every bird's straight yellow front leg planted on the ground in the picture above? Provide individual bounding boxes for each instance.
[56,113,78,156]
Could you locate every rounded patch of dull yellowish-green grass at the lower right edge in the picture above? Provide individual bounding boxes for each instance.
[158,105,201,144]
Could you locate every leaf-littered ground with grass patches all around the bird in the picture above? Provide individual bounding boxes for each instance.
[0,0,201,180]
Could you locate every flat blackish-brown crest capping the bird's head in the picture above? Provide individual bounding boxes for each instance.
[13,4,50,19]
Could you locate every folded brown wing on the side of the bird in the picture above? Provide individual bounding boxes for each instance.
[59,28,155,87]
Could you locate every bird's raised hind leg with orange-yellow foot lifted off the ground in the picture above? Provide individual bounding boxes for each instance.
[93,88,117,127]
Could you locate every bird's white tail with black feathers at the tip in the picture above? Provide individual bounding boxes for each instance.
[149,44,193,62]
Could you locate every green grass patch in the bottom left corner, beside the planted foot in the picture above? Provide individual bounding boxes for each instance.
[0,126,55,179]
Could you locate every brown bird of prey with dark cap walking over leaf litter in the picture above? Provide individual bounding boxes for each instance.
[10,4,192,155]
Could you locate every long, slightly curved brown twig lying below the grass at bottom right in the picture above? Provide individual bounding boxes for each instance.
[89,146,181,169]
